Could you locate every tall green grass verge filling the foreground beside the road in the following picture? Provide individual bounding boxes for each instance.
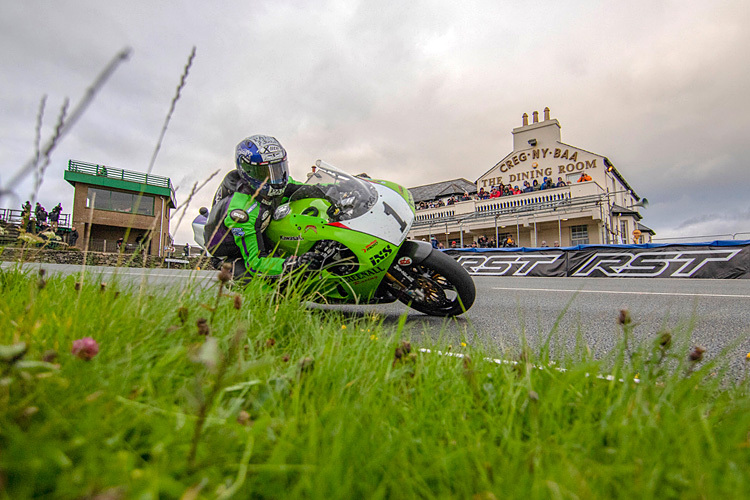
[0,264,750,499]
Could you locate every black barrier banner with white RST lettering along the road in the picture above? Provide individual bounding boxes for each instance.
[445,241,750,279]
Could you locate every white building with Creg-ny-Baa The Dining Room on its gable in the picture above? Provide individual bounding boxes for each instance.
[409,108,654,248]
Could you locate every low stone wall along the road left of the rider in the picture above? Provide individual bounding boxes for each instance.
[0,247,209,269]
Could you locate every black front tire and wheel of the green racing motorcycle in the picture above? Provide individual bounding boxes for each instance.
[390,250,476,316]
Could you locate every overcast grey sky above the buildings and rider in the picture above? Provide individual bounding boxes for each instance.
[0,0,750,244]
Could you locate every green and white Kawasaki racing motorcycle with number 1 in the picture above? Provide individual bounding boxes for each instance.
[194,160,476,316]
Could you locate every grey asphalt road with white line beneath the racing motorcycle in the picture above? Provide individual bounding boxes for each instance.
[1,263,750,373]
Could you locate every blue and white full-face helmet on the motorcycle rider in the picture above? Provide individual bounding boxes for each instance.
[235,135,289,196]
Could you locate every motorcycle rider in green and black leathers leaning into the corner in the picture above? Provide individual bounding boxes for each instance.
[204,135,322,277]
